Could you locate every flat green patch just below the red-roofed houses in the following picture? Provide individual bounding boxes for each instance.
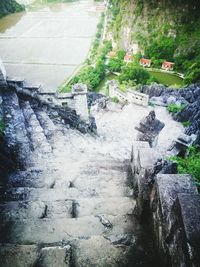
[147,69,183,87]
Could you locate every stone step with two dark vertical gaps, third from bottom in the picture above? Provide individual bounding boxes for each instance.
[0,197,135,221]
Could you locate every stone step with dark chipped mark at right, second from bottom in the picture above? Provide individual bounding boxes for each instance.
[0,215,135,244]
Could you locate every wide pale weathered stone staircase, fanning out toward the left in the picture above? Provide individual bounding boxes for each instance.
[0,92,138,267]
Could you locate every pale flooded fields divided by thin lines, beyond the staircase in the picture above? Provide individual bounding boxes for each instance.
[0,0,99,92]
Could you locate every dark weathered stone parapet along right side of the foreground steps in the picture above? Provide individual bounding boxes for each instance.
[131,142,200,267]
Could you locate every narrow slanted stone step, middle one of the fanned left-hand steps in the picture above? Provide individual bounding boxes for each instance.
[21,102,52,154]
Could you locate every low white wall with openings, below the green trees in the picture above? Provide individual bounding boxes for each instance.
[109,81,149,107]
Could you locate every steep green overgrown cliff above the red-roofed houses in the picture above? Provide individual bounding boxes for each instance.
[110,0,200,83]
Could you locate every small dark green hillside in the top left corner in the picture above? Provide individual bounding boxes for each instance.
[0,0,24,17]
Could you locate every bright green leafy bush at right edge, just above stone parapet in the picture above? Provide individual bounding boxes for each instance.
[170,146,200,189]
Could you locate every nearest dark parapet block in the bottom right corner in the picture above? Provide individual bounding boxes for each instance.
[167,194,200,267]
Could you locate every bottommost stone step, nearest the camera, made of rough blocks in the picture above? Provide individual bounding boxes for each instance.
[0,234,136,267]
